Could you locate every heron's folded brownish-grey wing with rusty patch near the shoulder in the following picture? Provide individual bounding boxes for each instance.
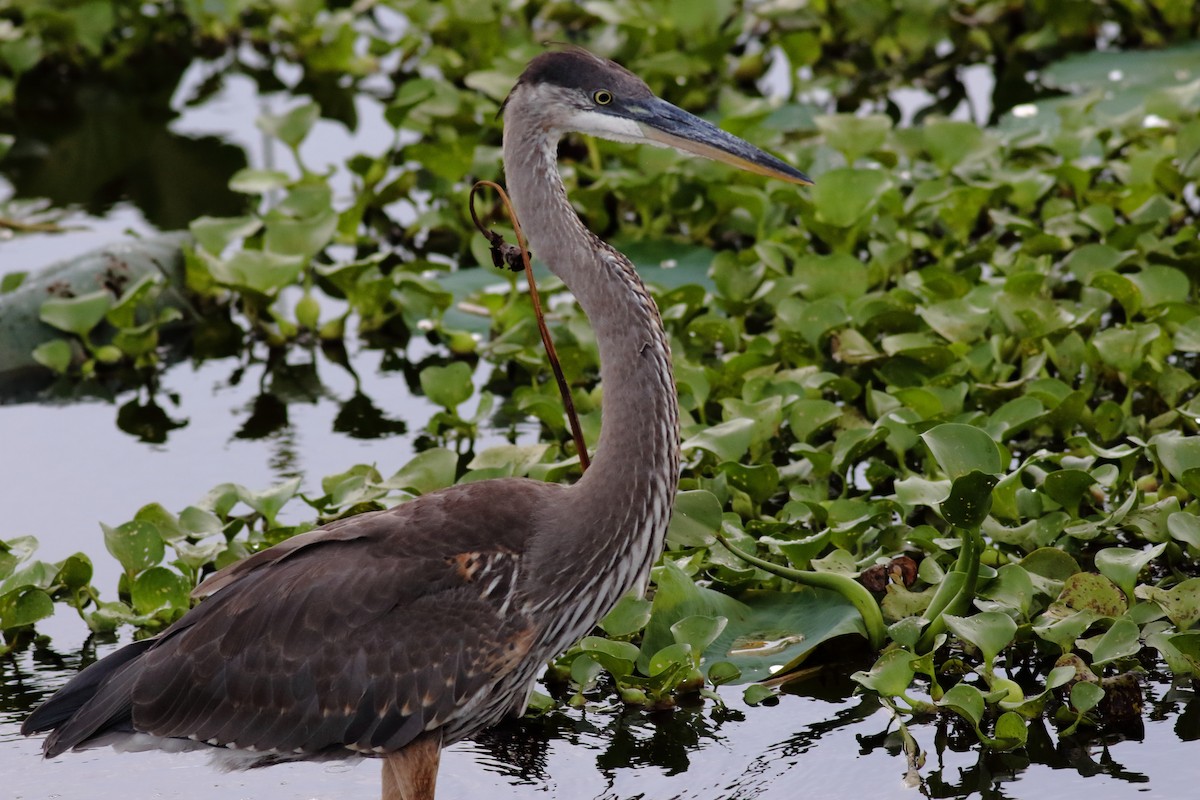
[34,481,562,754]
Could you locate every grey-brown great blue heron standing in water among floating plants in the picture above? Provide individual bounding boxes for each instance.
[22,48,810,800]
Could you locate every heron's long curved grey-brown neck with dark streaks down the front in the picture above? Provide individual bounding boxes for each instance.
[504,122,679,582]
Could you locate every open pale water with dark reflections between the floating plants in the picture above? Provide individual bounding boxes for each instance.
[0,17,1200,800]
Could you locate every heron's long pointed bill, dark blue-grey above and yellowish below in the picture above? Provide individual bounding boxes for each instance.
[623,97,812,186]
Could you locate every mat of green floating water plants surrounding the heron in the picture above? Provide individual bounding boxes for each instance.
[0,0,1200,786]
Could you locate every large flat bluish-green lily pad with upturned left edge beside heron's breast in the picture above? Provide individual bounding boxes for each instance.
[638,561,865,682]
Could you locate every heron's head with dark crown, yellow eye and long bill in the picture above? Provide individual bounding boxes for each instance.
[502,47,812,185]
